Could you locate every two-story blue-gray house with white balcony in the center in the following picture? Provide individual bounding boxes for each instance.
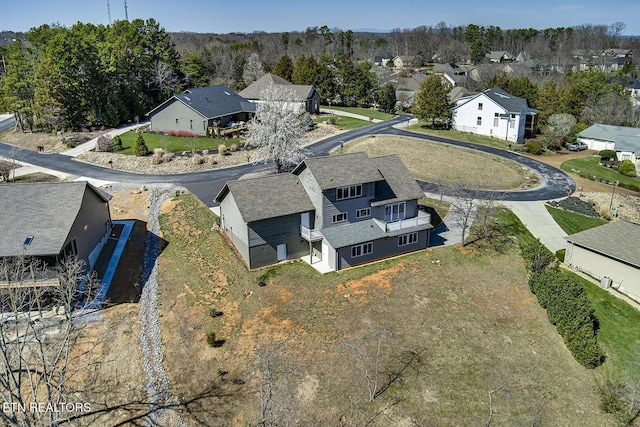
[215,153,433,270]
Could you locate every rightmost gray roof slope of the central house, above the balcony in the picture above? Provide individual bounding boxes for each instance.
[370,154,424,206]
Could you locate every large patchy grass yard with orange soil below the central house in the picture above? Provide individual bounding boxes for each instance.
[154,195,613,426]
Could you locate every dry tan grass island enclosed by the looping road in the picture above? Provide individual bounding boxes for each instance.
[344,136,538,190]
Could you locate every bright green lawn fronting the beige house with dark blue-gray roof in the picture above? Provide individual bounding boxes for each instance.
[118,131,240,155]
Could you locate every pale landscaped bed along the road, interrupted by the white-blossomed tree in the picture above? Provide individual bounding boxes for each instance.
[76,124,343,175]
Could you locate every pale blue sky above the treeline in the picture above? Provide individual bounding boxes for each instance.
[0,0,640,35]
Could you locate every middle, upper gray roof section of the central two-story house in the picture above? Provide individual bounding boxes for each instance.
[293,153,382,190]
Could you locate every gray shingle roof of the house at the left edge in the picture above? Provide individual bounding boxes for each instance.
[0,181,111,257]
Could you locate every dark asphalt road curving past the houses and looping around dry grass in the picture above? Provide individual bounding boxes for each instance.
[0,115,575,206]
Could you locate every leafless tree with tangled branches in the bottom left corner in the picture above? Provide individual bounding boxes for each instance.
[0,257,100,426]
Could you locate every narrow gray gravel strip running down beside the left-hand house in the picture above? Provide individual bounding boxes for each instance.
[140,189,185,426]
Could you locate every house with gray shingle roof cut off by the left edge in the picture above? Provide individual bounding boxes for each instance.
[0,181,111,284]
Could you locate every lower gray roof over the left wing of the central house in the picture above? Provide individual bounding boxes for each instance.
[216,173,315,223]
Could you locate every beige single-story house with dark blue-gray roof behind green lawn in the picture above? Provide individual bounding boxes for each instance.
[147,85,256,136]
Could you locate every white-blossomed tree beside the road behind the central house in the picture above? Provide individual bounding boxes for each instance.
[244,85,307,173]
